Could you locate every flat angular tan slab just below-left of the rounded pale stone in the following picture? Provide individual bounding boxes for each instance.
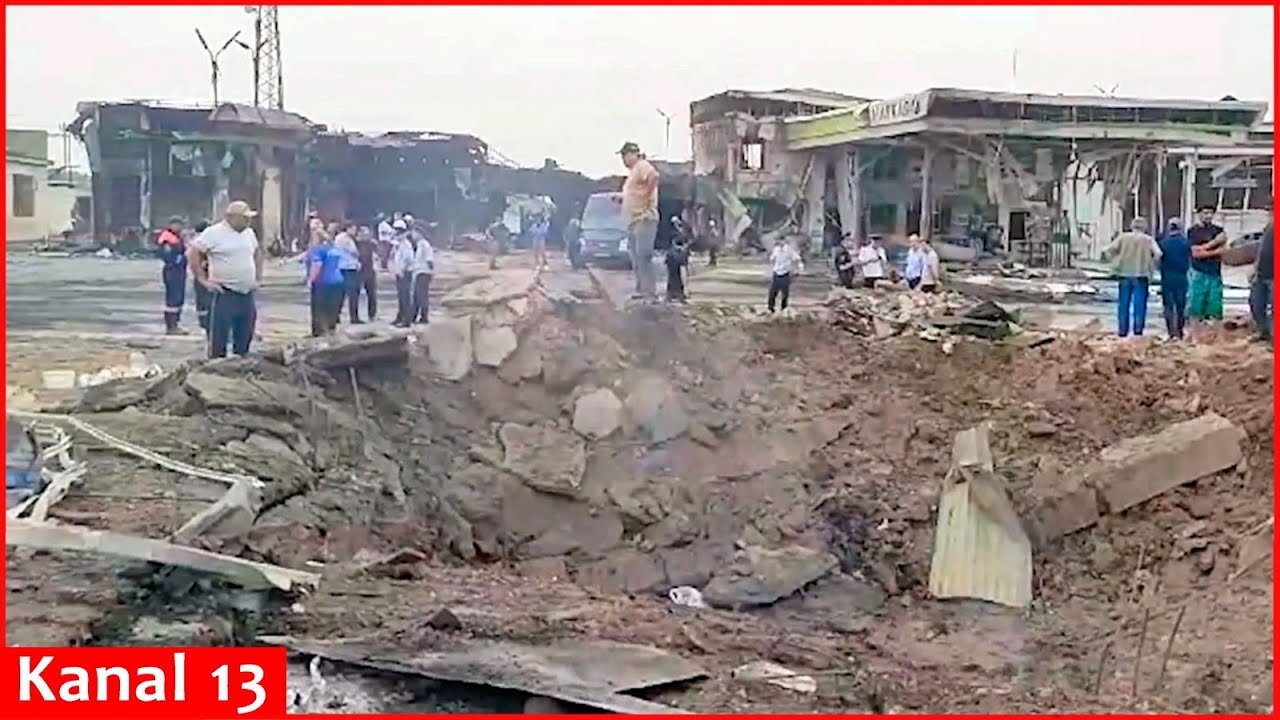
[498,423,586,497]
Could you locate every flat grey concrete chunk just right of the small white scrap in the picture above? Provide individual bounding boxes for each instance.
[703,546,838,609]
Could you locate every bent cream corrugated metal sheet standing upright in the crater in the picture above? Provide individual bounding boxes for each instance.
[929,424,1032,607]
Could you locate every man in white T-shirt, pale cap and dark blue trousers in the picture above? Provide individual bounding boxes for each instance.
[187,200,262,357]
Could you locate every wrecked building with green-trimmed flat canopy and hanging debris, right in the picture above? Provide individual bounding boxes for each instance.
[694,88,1271,266]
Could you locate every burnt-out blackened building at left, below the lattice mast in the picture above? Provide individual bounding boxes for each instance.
[68,101,316,247]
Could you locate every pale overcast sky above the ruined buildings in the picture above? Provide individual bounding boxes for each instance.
[5,6,1275,174]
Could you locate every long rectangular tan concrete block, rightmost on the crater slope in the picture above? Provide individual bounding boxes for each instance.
[1084,413,1244,512]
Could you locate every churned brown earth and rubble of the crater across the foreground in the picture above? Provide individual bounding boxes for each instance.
[6,253,1272,712]
